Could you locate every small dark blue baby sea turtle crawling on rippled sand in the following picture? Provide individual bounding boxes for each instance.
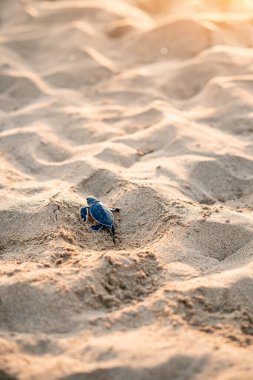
[80,197,120,244]
